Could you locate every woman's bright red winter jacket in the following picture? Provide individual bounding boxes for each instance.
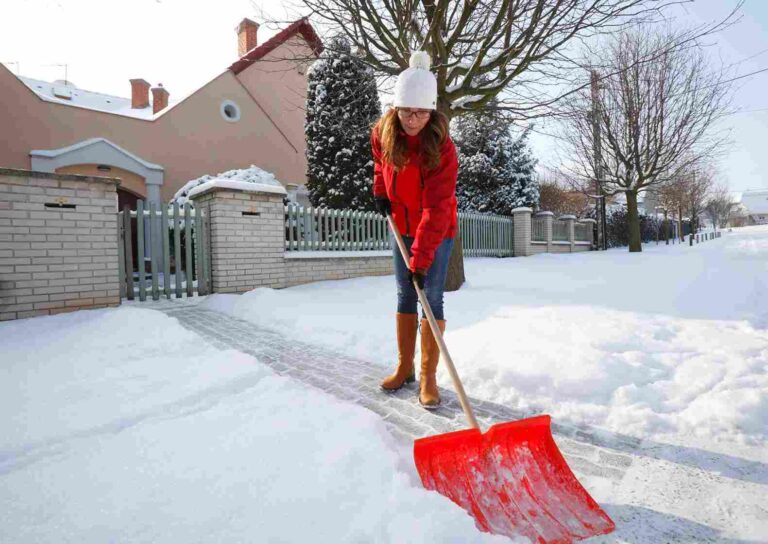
[371,129,459,270]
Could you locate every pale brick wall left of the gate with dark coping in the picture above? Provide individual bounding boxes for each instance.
[0,168,120,320]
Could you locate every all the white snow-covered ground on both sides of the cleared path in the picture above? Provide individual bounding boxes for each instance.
[0,227,768,543]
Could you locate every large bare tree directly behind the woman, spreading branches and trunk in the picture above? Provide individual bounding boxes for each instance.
[282,0,680,291]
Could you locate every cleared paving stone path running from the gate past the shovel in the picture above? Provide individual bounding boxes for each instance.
[140,299,768,544]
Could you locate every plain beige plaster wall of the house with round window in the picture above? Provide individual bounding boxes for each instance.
[0,36,306,200]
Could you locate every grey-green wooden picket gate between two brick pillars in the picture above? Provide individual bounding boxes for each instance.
[118,200,211,301]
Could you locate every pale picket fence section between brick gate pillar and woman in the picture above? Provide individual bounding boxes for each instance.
[285,204,390,251]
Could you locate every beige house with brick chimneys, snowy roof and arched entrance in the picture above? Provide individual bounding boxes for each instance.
[0,19,322,208]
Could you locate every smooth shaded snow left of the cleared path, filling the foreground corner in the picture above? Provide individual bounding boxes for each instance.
[0,307,506,543]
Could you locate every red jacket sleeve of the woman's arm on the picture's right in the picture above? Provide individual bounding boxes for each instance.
[409,138,459,270]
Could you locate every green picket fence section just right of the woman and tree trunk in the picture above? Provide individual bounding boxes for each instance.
[459,212,514,257]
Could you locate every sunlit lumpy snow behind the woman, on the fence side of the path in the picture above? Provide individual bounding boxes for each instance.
[205,227,768,450]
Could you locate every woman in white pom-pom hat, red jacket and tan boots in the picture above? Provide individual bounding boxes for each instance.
[371,51,458,409]
